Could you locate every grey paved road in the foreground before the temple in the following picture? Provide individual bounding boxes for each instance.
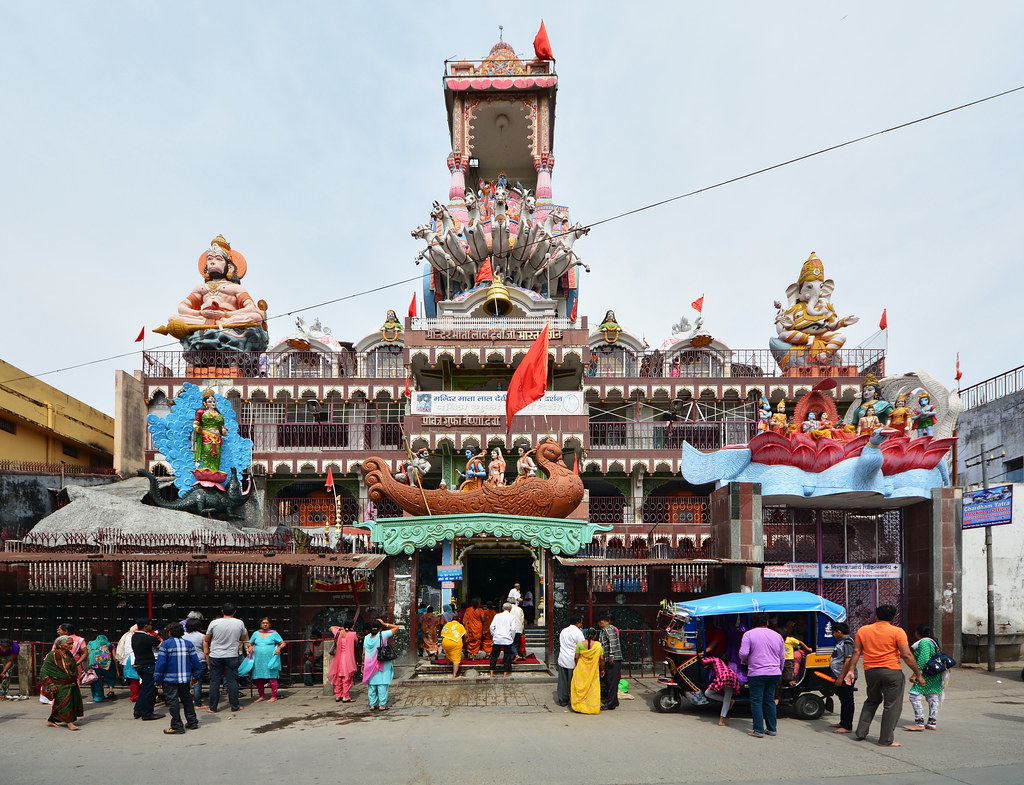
[0,667,1024,785]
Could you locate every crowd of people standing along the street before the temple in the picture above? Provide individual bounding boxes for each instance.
[0,597,947,746]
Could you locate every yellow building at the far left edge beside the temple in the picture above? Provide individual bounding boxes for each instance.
[0,360,114,470]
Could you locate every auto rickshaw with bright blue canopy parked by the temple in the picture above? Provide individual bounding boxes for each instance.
[654,592,846,719]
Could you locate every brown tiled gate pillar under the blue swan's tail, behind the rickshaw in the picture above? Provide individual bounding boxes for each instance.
[710,482,765,592]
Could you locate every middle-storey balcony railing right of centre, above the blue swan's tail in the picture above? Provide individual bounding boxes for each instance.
[589,420,757,450]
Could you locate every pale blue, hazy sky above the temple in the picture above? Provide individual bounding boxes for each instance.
[0,0,1024,413]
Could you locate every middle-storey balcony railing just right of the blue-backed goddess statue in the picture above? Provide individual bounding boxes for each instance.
[239,423,403,452]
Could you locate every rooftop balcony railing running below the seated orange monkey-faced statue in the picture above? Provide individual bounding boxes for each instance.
[142,347,407,379]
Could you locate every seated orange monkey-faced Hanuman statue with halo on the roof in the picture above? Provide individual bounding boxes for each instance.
[154,234,270,352]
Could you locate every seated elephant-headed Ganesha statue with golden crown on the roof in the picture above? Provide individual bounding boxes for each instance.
[768,252,859,372]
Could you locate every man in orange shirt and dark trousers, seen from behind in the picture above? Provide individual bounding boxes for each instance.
[840,605,925,747]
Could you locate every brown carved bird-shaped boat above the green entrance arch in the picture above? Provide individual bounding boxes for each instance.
[362,441,584,518]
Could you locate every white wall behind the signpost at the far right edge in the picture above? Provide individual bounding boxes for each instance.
[961,482,1024,636]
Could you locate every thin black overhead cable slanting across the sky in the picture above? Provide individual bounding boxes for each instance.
[0,85,1024,384]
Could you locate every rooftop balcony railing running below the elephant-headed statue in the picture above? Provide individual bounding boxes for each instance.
[587,345,886,379]
